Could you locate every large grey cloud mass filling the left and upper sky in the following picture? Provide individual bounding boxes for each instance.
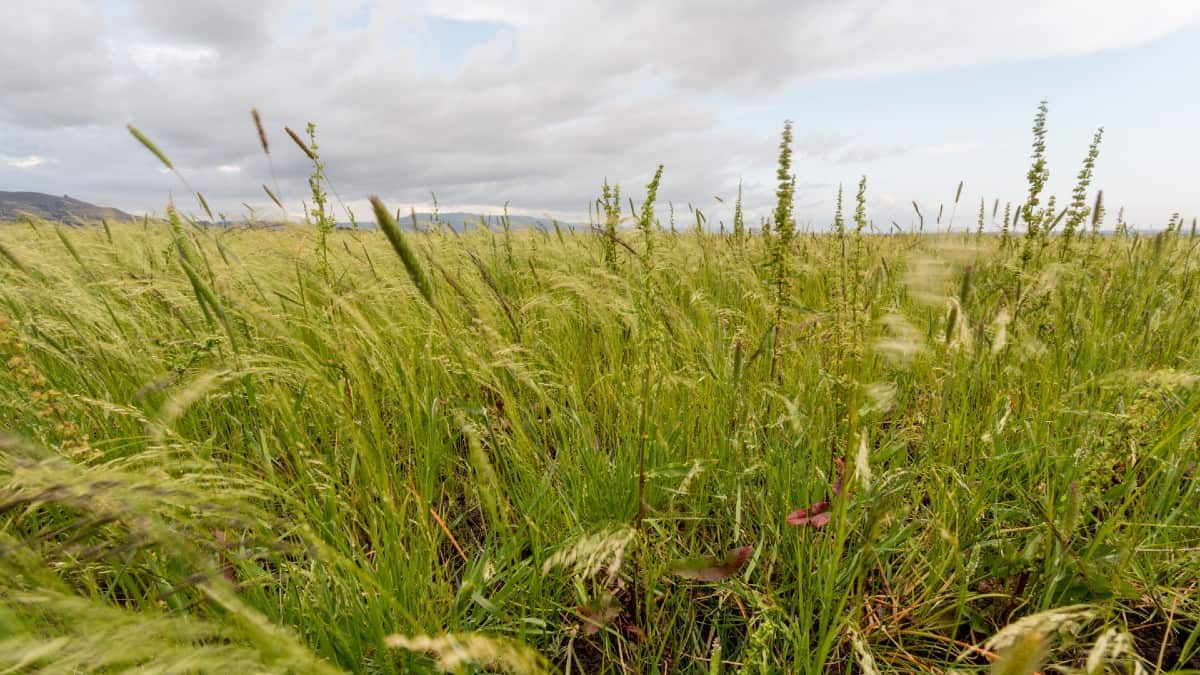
[0,0,1200,216]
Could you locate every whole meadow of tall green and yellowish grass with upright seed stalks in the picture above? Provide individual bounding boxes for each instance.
[0,110,1200,674]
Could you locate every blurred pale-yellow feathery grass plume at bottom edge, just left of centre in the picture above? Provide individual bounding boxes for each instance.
[384,633,554,675]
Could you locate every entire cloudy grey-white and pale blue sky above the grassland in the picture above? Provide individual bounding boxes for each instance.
[0,0,1200,229]
